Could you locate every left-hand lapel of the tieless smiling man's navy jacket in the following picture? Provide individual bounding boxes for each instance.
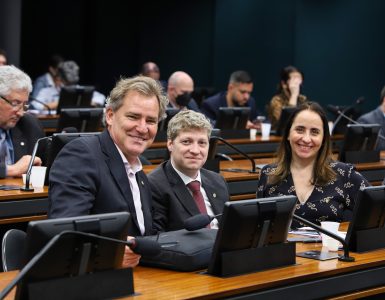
[99,130,139,228]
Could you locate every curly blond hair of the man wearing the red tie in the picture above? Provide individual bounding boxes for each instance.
[167,109,212,141]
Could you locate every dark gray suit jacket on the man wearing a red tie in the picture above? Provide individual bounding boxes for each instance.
[148,161,229,231]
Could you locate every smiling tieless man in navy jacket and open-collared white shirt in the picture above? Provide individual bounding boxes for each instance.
[48,76,168,267]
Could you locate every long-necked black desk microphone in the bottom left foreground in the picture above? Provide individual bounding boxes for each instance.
[0,230,160,299]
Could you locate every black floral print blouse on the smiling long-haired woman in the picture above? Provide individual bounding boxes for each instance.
[257,162,370,227]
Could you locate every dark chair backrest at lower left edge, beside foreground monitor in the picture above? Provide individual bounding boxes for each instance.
[1,229,26,272]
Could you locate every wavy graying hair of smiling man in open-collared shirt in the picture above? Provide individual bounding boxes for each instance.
[106,76,168,121]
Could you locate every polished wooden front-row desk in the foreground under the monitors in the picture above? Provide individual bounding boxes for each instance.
[0,243,385,300]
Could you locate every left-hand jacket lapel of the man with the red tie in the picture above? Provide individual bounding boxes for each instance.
[164,161,200,216]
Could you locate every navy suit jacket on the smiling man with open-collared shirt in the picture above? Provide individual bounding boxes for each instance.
[48,130,153,236]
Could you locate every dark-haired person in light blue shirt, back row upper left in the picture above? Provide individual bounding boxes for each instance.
[31,55,64,98]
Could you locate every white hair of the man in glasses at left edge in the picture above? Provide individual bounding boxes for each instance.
[0,65,32,97]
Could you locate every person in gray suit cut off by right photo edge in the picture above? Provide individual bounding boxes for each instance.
[357,86,385,150]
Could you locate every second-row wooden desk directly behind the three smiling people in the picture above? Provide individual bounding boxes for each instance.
[0,154,385,224]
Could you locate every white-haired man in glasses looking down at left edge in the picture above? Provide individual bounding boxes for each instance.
[0,66,45,178]
